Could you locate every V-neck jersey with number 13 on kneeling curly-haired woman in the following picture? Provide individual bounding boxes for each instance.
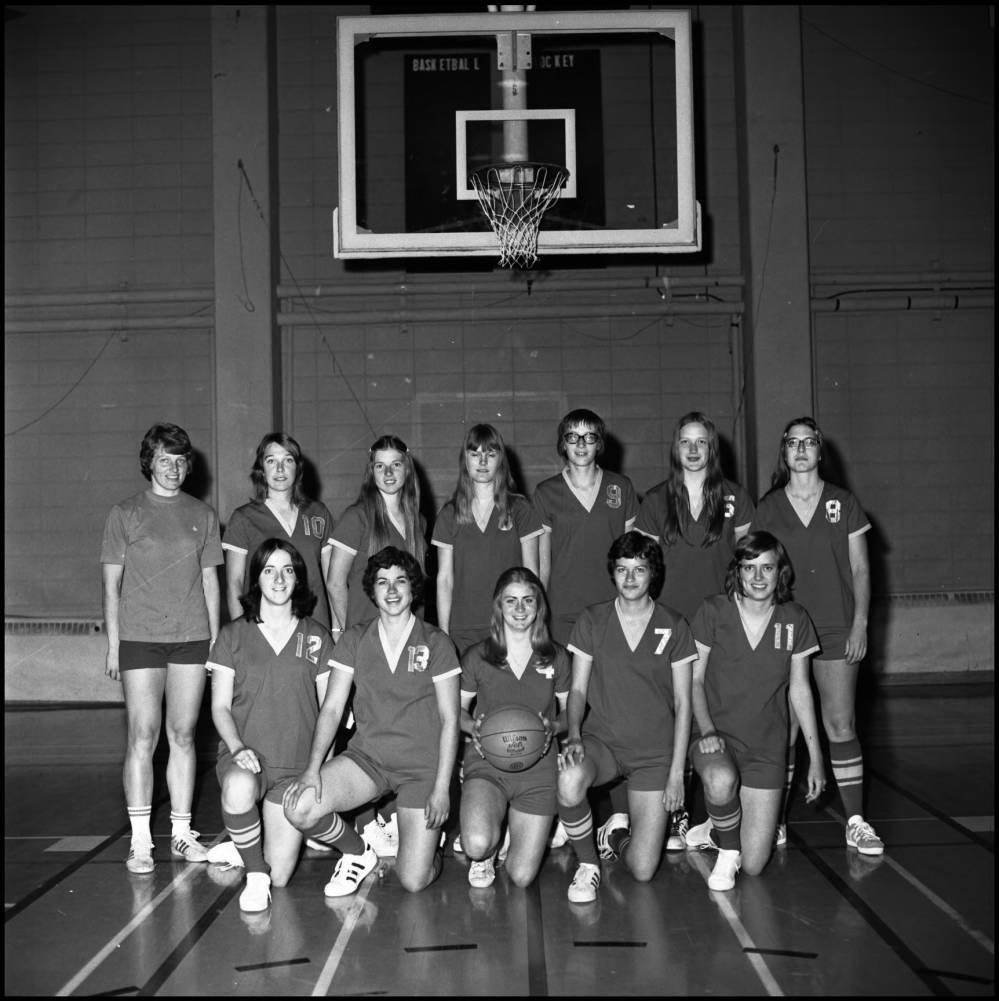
[333,616,461,771]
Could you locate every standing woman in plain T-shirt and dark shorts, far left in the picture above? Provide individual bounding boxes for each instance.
[101,423,222,873]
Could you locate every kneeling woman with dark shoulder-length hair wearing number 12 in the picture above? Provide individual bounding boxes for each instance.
[207,539,333,911]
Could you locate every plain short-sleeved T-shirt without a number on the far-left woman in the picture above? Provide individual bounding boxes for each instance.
[100,490,222,643]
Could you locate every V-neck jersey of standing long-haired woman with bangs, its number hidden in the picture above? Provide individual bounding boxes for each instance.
[432,494,544,632]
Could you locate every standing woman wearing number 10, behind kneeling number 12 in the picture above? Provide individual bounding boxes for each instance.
[222,431,333,629]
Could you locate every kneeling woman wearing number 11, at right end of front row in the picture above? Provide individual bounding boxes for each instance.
[687,532,826,890]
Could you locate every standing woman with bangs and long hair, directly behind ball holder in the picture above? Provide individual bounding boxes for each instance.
[432,424,545,653]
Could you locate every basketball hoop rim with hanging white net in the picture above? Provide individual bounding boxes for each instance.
[470,161,569,268]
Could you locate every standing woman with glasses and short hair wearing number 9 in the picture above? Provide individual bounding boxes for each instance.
[535,409,638,646]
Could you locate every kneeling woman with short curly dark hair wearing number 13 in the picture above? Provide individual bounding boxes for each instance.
[284,546,461,897]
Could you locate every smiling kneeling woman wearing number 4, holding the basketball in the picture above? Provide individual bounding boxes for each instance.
[461,567,570,887]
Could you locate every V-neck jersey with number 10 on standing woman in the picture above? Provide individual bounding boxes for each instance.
[222,501,333,627]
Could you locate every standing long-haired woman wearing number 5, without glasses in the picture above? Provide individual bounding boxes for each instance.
[635,410,753,851]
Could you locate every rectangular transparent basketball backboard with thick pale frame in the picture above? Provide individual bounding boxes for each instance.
[333,10,701,258]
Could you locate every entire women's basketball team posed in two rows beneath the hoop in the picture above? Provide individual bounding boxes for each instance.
[100,409,884,913]
